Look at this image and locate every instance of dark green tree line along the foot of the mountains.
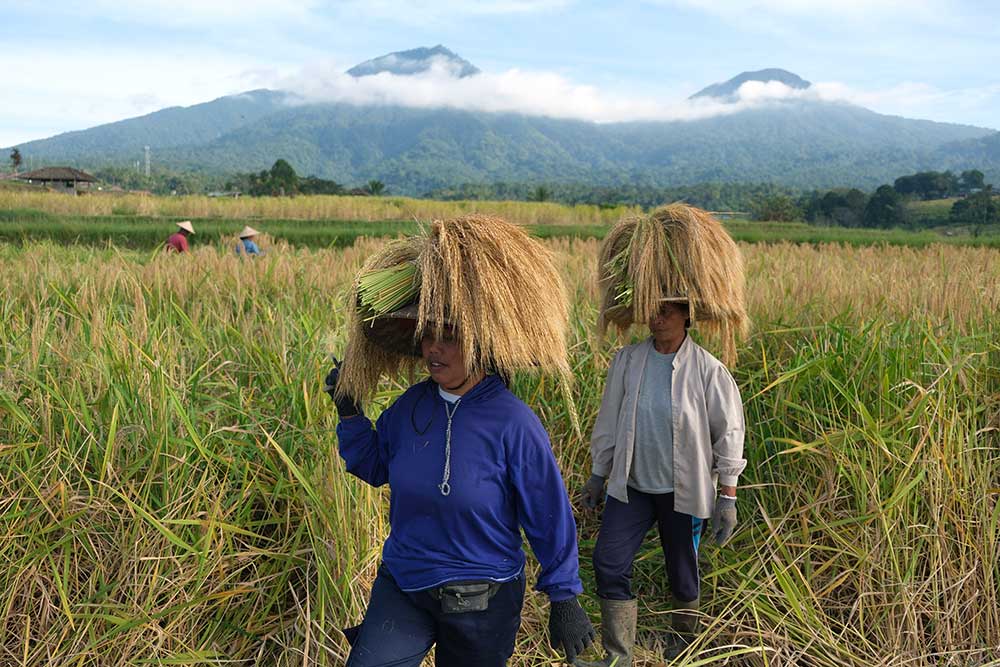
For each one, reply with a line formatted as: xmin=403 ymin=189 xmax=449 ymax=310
xmin=9 ymin=148 xmax=1000 ymax=233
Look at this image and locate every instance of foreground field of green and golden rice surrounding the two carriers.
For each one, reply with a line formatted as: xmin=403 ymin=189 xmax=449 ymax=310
xmin=0 ymin=237 xmax=1000 ymax=667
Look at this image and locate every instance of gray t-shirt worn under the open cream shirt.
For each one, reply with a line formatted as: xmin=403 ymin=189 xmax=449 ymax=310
xmin=628 ymin=347 xmax=674 ymax=493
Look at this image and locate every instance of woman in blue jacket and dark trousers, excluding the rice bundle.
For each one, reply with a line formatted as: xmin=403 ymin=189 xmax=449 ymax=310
xmin=327 ymin=215 xmax=594 ymax=667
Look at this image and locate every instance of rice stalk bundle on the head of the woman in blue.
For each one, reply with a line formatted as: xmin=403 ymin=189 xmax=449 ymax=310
xmin=340 ymin=214 xmax=571 ymax=410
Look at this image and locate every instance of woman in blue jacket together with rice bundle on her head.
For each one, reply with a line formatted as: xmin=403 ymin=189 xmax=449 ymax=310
xmin=326 ymin=215 xmax=594 ymax=667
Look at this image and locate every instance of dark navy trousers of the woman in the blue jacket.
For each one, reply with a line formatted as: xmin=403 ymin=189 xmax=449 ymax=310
xmin=347 ymin=567 xmax=524 ymax=667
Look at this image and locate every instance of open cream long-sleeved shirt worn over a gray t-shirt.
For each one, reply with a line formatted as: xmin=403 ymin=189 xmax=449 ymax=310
xmin=590 ymin=336 xmax=747 ymax=519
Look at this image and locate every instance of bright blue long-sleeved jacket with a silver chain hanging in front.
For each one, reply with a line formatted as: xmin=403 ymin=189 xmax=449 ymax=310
xmin=337 ymin=375 xmax=583 ymax=602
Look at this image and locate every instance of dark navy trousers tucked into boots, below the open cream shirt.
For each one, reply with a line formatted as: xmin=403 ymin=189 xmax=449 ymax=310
xmin=594 ymin=488 xmax=705 ymax=602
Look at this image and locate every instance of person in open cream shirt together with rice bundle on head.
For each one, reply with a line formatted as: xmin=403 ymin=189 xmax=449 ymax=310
xmin=577 ymin=204 xmax=747 ymax=667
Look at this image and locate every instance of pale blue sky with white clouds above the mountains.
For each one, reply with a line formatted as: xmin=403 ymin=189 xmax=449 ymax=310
xmin=0 ymin=0 xmax=1000 ymax=146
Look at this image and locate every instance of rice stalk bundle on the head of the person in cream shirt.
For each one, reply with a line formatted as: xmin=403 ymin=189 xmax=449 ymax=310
xmin=598 ymin=204 xmax=749 ymax=366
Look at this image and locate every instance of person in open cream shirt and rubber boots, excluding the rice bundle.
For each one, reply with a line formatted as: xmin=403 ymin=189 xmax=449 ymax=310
xmin=584 ymin=302 xmax=746 ymax=667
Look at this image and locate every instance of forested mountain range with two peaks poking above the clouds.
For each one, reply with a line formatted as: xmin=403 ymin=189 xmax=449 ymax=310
xmin=8 ymin=54 xmax=1000 ymax=195
